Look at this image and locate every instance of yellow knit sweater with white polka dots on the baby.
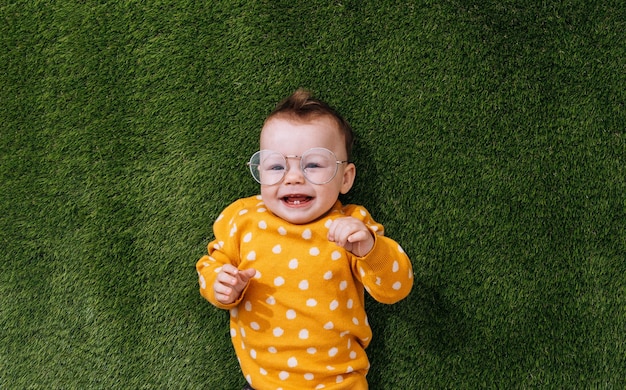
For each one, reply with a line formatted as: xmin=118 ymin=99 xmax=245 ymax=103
xmin=196 ymin=196 xmax=413 ymax=390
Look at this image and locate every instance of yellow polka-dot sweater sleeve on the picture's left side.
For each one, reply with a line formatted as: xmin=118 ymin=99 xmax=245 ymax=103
xmin=196 ymin=201 xmax=245 ymax=309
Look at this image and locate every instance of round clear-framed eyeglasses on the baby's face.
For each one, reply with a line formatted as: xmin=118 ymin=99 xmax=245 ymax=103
xmin=248 ymin=148 xmax=348 ymax=186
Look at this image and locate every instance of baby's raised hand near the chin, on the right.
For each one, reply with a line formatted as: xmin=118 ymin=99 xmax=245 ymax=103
xmin=328 ymin=217 xmax=374 ymax=257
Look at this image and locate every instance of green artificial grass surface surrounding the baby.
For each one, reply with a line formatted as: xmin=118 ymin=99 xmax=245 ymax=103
xmin=0 ymin=0 xmax=626 ymax=389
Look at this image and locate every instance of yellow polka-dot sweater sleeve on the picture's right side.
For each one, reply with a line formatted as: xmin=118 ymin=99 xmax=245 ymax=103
xmin=344 ymin=208 xmax=413 ymax=304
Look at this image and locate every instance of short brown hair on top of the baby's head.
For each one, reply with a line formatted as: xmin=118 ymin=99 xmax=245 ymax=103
xmin=265 ymin=88 xmax=354 ymax=161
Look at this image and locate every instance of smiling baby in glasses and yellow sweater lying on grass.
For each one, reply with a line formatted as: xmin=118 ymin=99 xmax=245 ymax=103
xmin=196 ymin=90 xmax=413 ymax=390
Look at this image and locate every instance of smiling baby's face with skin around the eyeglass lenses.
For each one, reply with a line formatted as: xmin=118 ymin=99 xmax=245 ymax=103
xmin=261 ymin=116 xmax=356 ymax=224
